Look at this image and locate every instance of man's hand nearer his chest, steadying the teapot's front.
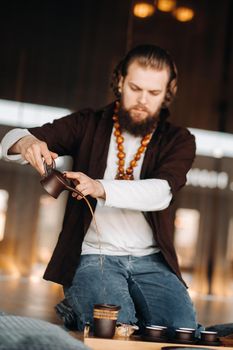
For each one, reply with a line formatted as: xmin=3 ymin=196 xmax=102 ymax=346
xmin=65 ymin=171 xmax=105 ymax=199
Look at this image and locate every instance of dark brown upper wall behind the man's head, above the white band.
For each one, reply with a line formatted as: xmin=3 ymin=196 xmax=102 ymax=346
xmin=0 ymin=0 xmax=233 ymax=132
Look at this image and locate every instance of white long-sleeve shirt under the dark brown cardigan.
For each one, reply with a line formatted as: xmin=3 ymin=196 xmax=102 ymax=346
xmin=2 ymin=129 xmax=172 ymax=256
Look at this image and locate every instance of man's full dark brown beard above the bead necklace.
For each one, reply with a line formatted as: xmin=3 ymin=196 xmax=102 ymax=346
xmin=118 ymin=104 xmax=161 ymax=137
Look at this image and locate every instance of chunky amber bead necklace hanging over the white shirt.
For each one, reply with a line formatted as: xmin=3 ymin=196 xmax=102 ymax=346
xmin=113 ymin=101 xmax=153 ymax=180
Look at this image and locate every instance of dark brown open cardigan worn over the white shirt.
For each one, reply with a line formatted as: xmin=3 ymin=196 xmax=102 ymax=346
xmin=29 ymin=104 xmax=195 ymax=285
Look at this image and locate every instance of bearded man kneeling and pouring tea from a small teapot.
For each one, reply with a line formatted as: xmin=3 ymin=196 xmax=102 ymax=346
xmin=2 ymin=45 xmax=198 ymax=330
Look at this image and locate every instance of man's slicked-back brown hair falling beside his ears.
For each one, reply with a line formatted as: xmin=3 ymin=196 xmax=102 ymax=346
xmin=111 ymin=45 xmax=177 ymax=109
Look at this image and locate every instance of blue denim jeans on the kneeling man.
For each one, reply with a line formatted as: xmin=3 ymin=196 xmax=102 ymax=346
xmin=64 ymin=253 xmax=198 ymax=330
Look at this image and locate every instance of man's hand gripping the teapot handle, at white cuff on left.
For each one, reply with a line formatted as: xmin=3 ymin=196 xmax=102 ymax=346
xmin=8 ymin=135 xmax=58 ymax=175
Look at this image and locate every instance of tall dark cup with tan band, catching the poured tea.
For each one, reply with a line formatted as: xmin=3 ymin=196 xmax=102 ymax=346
xmin=93 ymin=304 xmax=121 ymax=338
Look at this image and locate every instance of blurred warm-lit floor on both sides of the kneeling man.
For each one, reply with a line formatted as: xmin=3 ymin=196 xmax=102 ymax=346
xmin=0 ymin=276 xmax=233 ymax=326
